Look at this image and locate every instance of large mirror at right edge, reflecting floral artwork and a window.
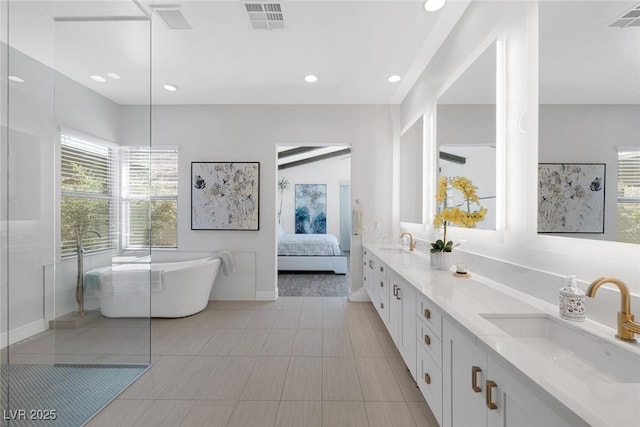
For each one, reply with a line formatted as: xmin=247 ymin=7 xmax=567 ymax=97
xmin=538 ymin=0 xmax=640 ymax=243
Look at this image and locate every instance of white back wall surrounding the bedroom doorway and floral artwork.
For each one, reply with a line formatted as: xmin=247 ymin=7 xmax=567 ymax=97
xmin=117 ymin=105 xmax=394 ymax=299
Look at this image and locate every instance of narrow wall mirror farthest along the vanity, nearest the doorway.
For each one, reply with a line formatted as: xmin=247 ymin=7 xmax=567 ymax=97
xmin=400 ymin=116 xmax=424 ymax=224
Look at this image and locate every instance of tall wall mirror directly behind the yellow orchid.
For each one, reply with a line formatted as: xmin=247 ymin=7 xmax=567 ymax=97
xmin=436 ymin=42 xmax=497 ymax=230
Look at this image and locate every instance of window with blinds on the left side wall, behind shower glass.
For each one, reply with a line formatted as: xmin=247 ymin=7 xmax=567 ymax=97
xmin=60 ymin=133 xmax=116 ymax=257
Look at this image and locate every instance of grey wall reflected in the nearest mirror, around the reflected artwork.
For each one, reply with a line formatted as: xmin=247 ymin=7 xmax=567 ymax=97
xmin=539 ymin=105 xmax=640 ymax=240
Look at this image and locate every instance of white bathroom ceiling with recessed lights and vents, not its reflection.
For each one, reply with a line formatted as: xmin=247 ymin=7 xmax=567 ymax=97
xmin=2 ymin=0 xmax=468 ymax=105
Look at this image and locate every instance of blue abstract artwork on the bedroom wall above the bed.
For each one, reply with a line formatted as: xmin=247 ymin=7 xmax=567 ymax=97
xmin=296 ymin=184 xmax=327 ymax=234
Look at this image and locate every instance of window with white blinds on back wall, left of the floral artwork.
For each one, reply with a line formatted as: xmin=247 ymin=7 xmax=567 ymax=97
xmin=122 ymin=147 xmax=178 ymax=249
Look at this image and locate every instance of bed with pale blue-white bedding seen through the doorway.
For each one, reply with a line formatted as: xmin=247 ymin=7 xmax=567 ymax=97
xmin=278 ymin=227 xmax=347 ymax=274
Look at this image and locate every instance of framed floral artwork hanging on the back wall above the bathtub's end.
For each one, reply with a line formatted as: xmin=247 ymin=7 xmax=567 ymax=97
xmin=191 ymin=162 xmax=260 ymax=230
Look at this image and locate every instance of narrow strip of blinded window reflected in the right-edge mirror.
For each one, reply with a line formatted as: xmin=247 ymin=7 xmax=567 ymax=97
xmin=616 ymin=149 xmax=640 ymax=243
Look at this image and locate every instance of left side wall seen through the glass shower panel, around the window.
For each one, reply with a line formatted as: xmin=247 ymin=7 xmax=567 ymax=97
xmin=0 ymin=45 xmax=120 ymax=342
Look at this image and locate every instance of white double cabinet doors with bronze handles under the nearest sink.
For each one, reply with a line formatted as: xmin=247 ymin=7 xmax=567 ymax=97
xmin=441 ymin=321 xmax=584 ymax=427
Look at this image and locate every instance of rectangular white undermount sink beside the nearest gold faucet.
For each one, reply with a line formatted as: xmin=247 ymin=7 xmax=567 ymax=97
xmin=481 ymin=314 xmax=640 ymax=383
